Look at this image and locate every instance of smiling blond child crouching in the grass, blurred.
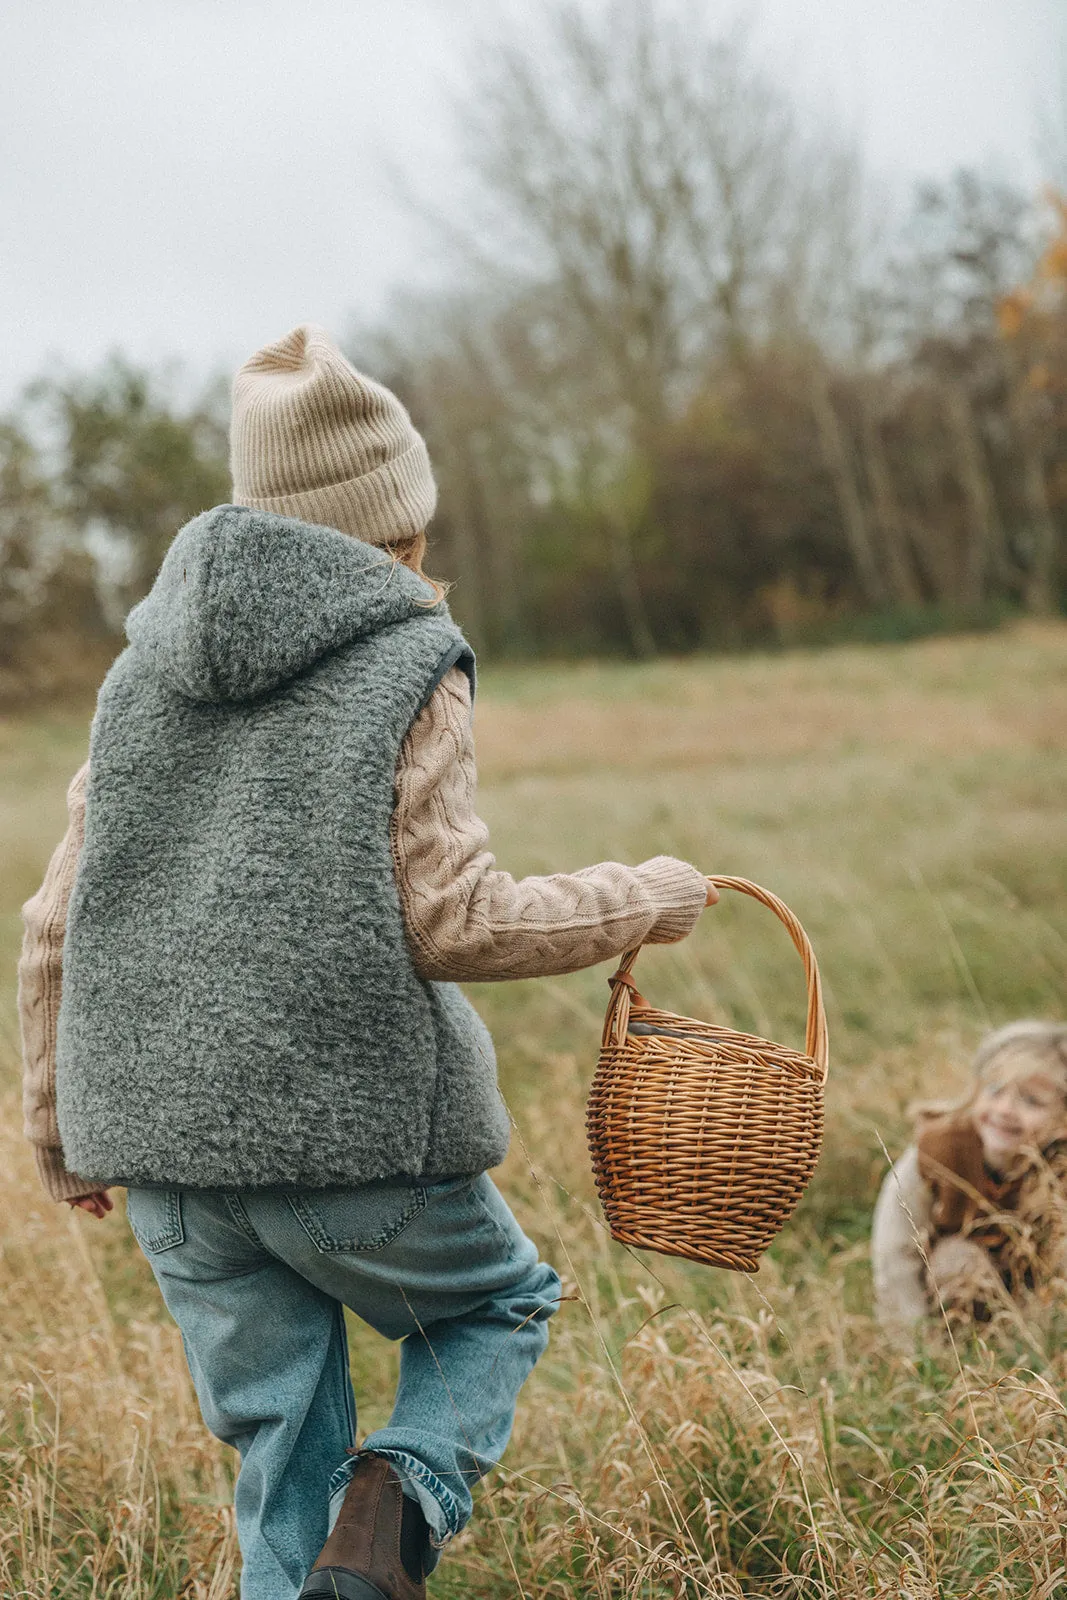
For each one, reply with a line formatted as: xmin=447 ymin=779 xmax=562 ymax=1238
xmin=870 ymin=1022 xmax=1067 ymax=1333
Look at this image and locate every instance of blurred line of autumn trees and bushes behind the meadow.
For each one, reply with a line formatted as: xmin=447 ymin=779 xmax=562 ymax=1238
xmin=0 ymin=0 xmax=1067 ymax=699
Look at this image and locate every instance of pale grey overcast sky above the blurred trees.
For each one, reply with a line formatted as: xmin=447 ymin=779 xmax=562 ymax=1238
xmin=0 ymin=0 xmax=1067 ymax=403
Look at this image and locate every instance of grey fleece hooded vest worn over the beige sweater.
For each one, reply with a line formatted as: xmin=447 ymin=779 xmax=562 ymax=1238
xmin=56 ymin=506 xmax=507 ymax=1189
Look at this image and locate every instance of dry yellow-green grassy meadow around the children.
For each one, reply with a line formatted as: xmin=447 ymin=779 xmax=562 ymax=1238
xmin=0 ymin=626 xmax=1067 ymax=1600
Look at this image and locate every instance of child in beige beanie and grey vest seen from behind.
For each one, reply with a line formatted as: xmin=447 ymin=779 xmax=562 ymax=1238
xmin=19 ymin=326 xmax=717 ymax=1600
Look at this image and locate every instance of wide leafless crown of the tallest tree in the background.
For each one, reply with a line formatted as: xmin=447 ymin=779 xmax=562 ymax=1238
xmin=462 ymin=0 xmax=870 ymax=412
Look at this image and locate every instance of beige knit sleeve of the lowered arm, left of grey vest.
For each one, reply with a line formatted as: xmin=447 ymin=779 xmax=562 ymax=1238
xmin=19 ymin=765 xmax=96 ymax=1200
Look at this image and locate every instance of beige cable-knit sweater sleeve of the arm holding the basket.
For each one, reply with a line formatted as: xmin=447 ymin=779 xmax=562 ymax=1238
xmin=392 ymin=669 xmax=707 ymax=982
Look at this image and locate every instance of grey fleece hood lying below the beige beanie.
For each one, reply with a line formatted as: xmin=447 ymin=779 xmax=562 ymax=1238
xmin=126 ymin=506 xmax=448 ymax=701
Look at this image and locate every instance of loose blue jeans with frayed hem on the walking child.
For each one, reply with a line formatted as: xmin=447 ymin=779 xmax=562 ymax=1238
xmin=126 ymin=1174 xmax=560 ymax=1600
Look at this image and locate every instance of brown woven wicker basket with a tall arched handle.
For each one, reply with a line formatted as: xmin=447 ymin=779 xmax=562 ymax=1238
xmin=587 ymin=877 xmax=829 ymax=1272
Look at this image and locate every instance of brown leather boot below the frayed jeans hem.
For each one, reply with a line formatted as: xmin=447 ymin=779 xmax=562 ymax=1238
xmin=299 ymin=1456 xmax=429 ymax=1600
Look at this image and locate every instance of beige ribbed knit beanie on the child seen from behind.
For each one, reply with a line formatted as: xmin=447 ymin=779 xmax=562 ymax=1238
xmin=230 ymin=323 xmax=437 ymax=544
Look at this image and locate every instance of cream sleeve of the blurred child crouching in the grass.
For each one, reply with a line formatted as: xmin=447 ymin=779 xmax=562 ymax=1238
xmin=870 ymin=1144 xmax=931 ymax=1336
